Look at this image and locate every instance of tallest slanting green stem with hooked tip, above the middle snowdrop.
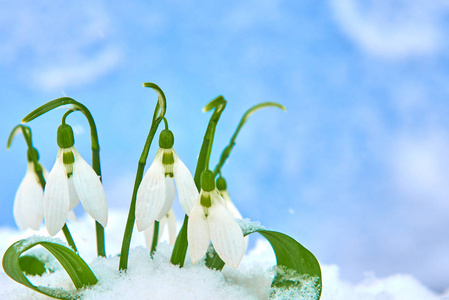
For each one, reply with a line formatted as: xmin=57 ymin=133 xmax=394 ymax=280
xmin=119 ymin=83 xmax=166 ymax=271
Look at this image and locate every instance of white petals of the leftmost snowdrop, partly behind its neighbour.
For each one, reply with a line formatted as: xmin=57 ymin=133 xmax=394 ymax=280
xmin=13 ymin=162 xmax=47 ymax=230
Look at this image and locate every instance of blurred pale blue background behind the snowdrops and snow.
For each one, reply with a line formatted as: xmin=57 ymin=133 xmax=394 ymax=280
xmin=0 ymin=0 xmax=449 ymax=291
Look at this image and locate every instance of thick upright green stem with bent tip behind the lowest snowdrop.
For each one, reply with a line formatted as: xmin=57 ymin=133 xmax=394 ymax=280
xmin=170 ymin=96 xmax=226 ymax=268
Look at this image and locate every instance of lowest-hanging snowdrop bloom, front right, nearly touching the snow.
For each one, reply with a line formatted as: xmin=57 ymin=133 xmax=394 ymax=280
xmin=187 ymin=170 xmax=245 ymax=268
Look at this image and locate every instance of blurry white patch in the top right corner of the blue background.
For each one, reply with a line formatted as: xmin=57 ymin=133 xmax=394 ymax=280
xmin=331 ymin=0 xmax=449 ymax=59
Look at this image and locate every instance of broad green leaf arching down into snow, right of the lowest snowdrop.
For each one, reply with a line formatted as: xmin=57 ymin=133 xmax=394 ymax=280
xmin=206 ymin=228 xmax=321 ymax=299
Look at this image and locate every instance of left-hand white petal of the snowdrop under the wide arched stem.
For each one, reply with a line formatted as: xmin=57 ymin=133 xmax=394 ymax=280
xmin=44 ymin=149 xmax=70 ymax=236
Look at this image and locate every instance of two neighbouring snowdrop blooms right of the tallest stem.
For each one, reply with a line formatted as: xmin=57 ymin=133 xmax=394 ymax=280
xmin=136 ymin=130 xmax=245 ymax=268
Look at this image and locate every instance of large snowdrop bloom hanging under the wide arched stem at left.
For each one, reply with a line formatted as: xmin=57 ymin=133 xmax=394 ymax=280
xmin=44 ymin=124 xmax=108 ymax=236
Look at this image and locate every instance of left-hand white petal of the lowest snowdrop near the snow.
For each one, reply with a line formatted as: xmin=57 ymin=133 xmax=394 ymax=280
xmin=187 ymin=198 xmax=210 ymax=264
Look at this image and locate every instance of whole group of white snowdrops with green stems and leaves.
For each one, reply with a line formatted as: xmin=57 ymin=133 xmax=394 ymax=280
xmin=3 ymin=87 xmax=321 ymax=299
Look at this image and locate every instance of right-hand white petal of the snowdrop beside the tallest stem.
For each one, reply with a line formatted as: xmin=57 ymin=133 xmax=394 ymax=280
xmin=173 ymin=150 xmax=199 ymax=215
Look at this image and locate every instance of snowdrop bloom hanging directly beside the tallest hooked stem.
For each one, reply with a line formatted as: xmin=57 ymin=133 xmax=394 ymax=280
xmin=136 ymin=129 xmax=198 ymax=231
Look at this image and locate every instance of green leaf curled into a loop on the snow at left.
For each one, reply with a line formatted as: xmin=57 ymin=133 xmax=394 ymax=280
xmin=3 ymin=237 xmax=98 ymax=300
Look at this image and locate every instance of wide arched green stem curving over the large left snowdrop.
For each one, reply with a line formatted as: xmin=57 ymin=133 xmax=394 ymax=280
xmin=22 ymin=97 xmax=106 ymax=257
